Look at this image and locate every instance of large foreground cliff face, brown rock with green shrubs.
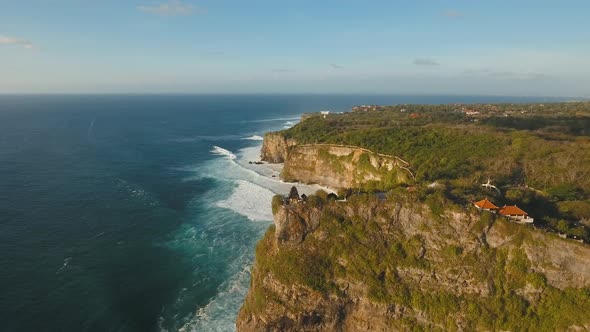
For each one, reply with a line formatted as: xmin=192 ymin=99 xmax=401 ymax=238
xmin=237 ymin=196 xmax=590 ymax=331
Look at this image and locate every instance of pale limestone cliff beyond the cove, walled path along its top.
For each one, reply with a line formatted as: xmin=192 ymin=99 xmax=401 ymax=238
xmin=281 ymin=144 xmax=413 ymax=188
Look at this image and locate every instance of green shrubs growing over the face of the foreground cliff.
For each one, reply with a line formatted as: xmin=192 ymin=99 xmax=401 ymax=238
xmin=245 ymin=191 xmax=590 ymax=331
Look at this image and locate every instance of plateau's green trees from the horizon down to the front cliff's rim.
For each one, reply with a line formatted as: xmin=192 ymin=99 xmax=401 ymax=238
xmin=281 ymin=102 xmax=590 ymax=242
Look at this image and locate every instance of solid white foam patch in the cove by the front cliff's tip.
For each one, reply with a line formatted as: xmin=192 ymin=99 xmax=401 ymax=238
xmin=216 ymin=180 xmax=274 ymax=221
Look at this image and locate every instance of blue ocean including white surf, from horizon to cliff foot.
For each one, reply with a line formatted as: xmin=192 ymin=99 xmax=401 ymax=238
xmin=0 ymin=95 xmax=568 ymax=331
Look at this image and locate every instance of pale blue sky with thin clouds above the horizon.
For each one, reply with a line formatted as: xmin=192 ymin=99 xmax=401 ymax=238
xmin=0 ymin=0 xmax=590 ymax=97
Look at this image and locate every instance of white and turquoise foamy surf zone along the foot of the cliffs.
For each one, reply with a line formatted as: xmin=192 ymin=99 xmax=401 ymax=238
xmin=169 ymin=144 xmax=340 ymax=332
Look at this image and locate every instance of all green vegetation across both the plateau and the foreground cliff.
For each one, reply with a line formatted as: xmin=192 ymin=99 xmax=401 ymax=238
xmin=244 ymin=102 xmax=590 ymax=331
